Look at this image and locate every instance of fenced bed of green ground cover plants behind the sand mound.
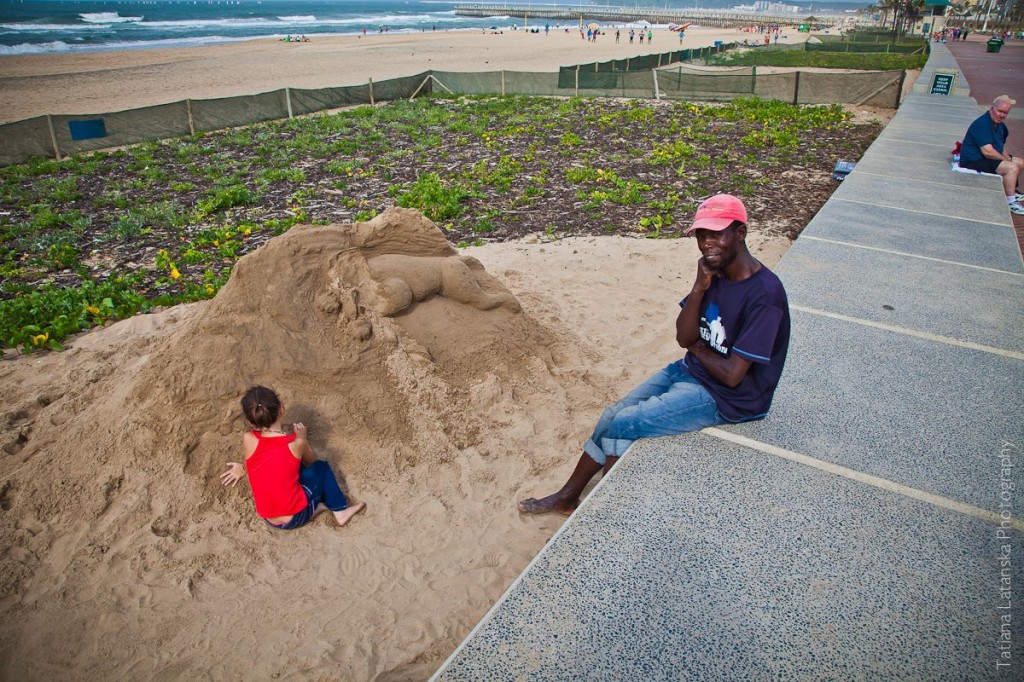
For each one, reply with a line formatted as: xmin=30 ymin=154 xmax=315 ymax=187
xmin=0 ymin=94 xmax=881 ymax=350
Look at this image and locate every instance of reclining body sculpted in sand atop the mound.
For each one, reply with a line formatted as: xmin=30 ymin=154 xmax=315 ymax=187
xmin=367 ymin=254 xmax=520 ymax=316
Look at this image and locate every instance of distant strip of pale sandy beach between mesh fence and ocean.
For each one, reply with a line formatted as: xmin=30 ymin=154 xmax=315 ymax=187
xmin=0 ymin=27 xmax=807 ymax=123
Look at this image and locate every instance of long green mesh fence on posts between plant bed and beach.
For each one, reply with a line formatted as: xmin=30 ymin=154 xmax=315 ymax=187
xmin=0 ymin=53 xmax=903 ymax=165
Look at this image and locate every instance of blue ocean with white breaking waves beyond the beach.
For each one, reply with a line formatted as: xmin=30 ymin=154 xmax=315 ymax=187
xmin=0 ymin=0 xmax=514 ymax=55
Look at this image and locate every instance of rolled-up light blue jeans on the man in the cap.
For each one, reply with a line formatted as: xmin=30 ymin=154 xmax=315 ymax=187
xmin=583 ymin=359 xmax=727 ymax=465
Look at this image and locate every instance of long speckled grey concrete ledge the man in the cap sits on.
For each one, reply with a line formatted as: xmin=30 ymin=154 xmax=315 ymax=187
xmin=434 ymin=45 xmax=1024 ymax=682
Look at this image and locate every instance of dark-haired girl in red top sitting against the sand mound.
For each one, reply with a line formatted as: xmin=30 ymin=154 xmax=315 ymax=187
xmin=220 ymin=386 xmax=367 ymax=530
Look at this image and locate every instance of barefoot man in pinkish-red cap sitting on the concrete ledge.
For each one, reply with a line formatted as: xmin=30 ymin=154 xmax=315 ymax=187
xmin=519 ymin=195 xmax=790 ymax=514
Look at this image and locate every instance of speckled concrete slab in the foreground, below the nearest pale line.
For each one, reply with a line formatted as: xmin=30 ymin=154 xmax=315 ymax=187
xmin=434 ymin=434 xmax=1024 ymax=682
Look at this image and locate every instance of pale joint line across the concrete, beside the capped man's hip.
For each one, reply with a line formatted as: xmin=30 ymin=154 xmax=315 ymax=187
xmin=701 ymin=427 xmax=1024 ymax=530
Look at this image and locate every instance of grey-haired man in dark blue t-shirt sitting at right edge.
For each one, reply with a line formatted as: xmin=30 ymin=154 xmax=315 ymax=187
xmin=959 ymin=95 xmax=1024 ymax=215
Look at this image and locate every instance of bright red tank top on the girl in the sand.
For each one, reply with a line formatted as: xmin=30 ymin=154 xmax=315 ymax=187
xmin=246 ymin=431 xmax=309 ymax=518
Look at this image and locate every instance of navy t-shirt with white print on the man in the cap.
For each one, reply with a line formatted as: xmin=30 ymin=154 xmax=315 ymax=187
xmin=679 ymin=265 xmax=790 ymax=422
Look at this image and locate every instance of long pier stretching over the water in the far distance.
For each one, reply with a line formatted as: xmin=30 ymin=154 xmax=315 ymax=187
xmin=455 ymin=2 xmax=837 ymax=28
